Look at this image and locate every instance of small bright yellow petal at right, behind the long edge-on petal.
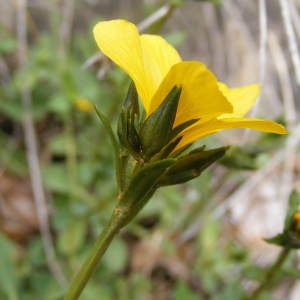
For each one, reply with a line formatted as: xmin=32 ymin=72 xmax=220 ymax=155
xmin=218 ymin=82 xmax=260 ymax=118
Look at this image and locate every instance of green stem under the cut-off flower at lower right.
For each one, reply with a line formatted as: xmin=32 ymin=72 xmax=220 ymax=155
xmin=246 ymin=248 xmax=290 ymax=300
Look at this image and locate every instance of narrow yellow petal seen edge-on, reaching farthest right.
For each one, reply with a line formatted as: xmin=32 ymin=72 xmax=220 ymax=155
xmin=176 ymin=118 xmax=287 ymax=149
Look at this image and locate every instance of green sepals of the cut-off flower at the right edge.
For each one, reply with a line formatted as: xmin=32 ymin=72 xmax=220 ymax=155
xmin=265 ymin=191 xmax=300 ymax=249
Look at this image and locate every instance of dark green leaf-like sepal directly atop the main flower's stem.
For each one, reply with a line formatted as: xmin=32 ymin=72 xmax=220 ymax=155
xmin=117 ymin=158 xmax=175 ymax=223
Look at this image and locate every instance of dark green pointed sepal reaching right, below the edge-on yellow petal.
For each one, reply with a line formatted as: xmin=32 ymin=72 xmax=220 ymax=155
xmin=159 ymin=147 xmax=228 ymax=186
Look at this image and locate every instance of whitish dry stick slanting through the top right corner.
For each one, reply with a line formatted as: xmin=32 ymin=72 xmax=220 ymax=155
xmin=278 ymin=0 xmax=300 ymax=85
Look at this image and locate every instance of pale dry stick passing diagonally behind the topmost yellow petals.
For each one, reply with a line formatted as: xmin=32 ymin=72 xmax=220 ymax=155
xmin=82 ymin=3 xmax=176 ymax=69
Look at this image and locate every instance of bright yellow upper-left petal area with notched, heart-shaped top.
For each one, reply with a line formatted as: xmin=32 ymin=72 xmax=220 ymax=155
xmin=94 ymin=20 xmax=181 ymax=112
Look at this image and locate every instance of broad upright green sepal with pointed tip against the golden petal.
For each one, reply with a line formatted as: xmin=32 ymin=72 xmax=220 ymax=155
xmin=140 ymin=86 xmax=181 ymax=161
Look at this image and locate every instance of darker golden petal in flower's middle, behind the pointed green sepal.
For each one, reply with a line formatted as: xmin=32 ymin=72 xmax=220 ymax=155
xmin=150 ymin=61 xmax=232 ymax=126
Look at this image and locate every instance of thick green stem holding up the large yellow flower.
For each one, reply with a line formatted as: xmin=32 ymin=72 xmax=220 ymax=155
xmin=63 ymin=210 xmax=124 ymax=300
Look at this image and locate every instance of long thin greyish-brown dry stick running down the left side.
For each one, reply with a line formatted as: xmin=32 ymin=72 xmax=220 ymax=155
xmin=17 ymin=0 xmax=66 ymax=286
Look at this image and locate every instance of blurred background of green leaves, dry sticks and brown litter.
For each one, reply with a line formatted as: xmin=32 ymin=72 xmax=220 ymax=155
xmin=0 ymin=0 xmax=300 ymax=300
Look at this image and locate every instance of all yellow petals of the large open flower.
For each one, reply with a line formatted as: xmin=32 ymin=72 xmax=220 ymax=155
xmin=94 ymin=20 xmax=286 ymax=149
